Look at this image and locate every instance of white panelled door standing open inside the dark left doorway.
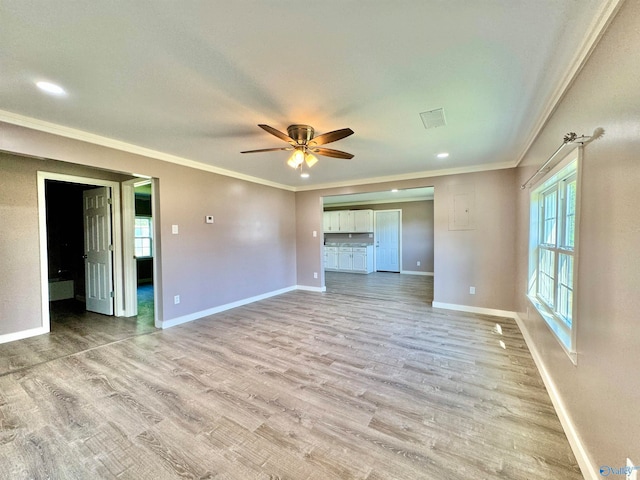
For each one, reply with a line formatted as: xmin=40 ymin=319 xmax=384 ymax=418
xmin=83 ymin=187 xmax=113 ymax=315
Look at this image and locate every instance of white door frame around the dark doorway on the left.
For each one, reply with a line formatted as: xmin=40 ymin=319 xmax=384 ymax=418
xmin=37 ymin=171 xmax=124 ymax=333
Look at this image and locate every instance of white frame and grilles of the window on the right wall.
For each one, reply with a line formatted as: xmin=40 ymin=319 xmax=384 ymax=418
xmin=527 ymin=147 xmax=582 ymax=364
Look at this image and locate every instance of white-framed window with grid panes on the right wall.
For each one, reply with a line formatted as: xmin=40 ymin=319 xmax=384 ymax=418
xmin=528 ymin=151 xmax=580 ymax=362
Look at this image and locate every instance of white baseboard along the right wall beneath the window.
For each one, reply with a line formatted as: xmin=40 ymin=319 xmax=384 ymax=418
xmin=513 ymin=313 xmax=602 ymax=480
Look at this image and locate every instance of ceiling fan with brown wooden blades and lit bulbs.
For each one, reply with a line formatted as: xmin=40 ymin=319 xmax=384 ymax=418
xmin=240 ymin=124 xmax=353 ymax=168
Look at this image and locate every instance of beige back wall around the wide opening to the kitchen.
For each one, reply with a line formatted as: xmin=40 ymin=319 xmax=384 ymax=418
xmin=296 ymin=169 xmax=517 ymax=312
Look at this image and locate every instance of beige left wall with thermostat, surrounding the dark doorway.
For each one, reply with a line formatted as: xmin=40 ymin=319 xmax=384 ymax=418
xmin=0 ymin=124 xmax=296 ymax=335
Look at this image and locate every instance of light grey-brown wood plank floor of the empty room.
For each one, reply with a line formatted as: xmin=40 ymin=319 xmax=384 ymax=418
xmin=0 ymin=275 xmax=582 ymax=480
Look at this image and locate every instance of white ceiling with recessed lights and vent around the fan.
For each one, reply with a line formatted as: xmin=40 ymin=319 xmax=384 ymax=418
xmin=0 ymin=0 xmax=619 ymax=190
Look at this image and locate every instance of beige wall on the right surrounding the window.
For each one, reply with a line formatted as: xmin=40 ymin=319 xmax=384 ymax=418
xmin=515 ymin=0 xmax=640 ymax=472
